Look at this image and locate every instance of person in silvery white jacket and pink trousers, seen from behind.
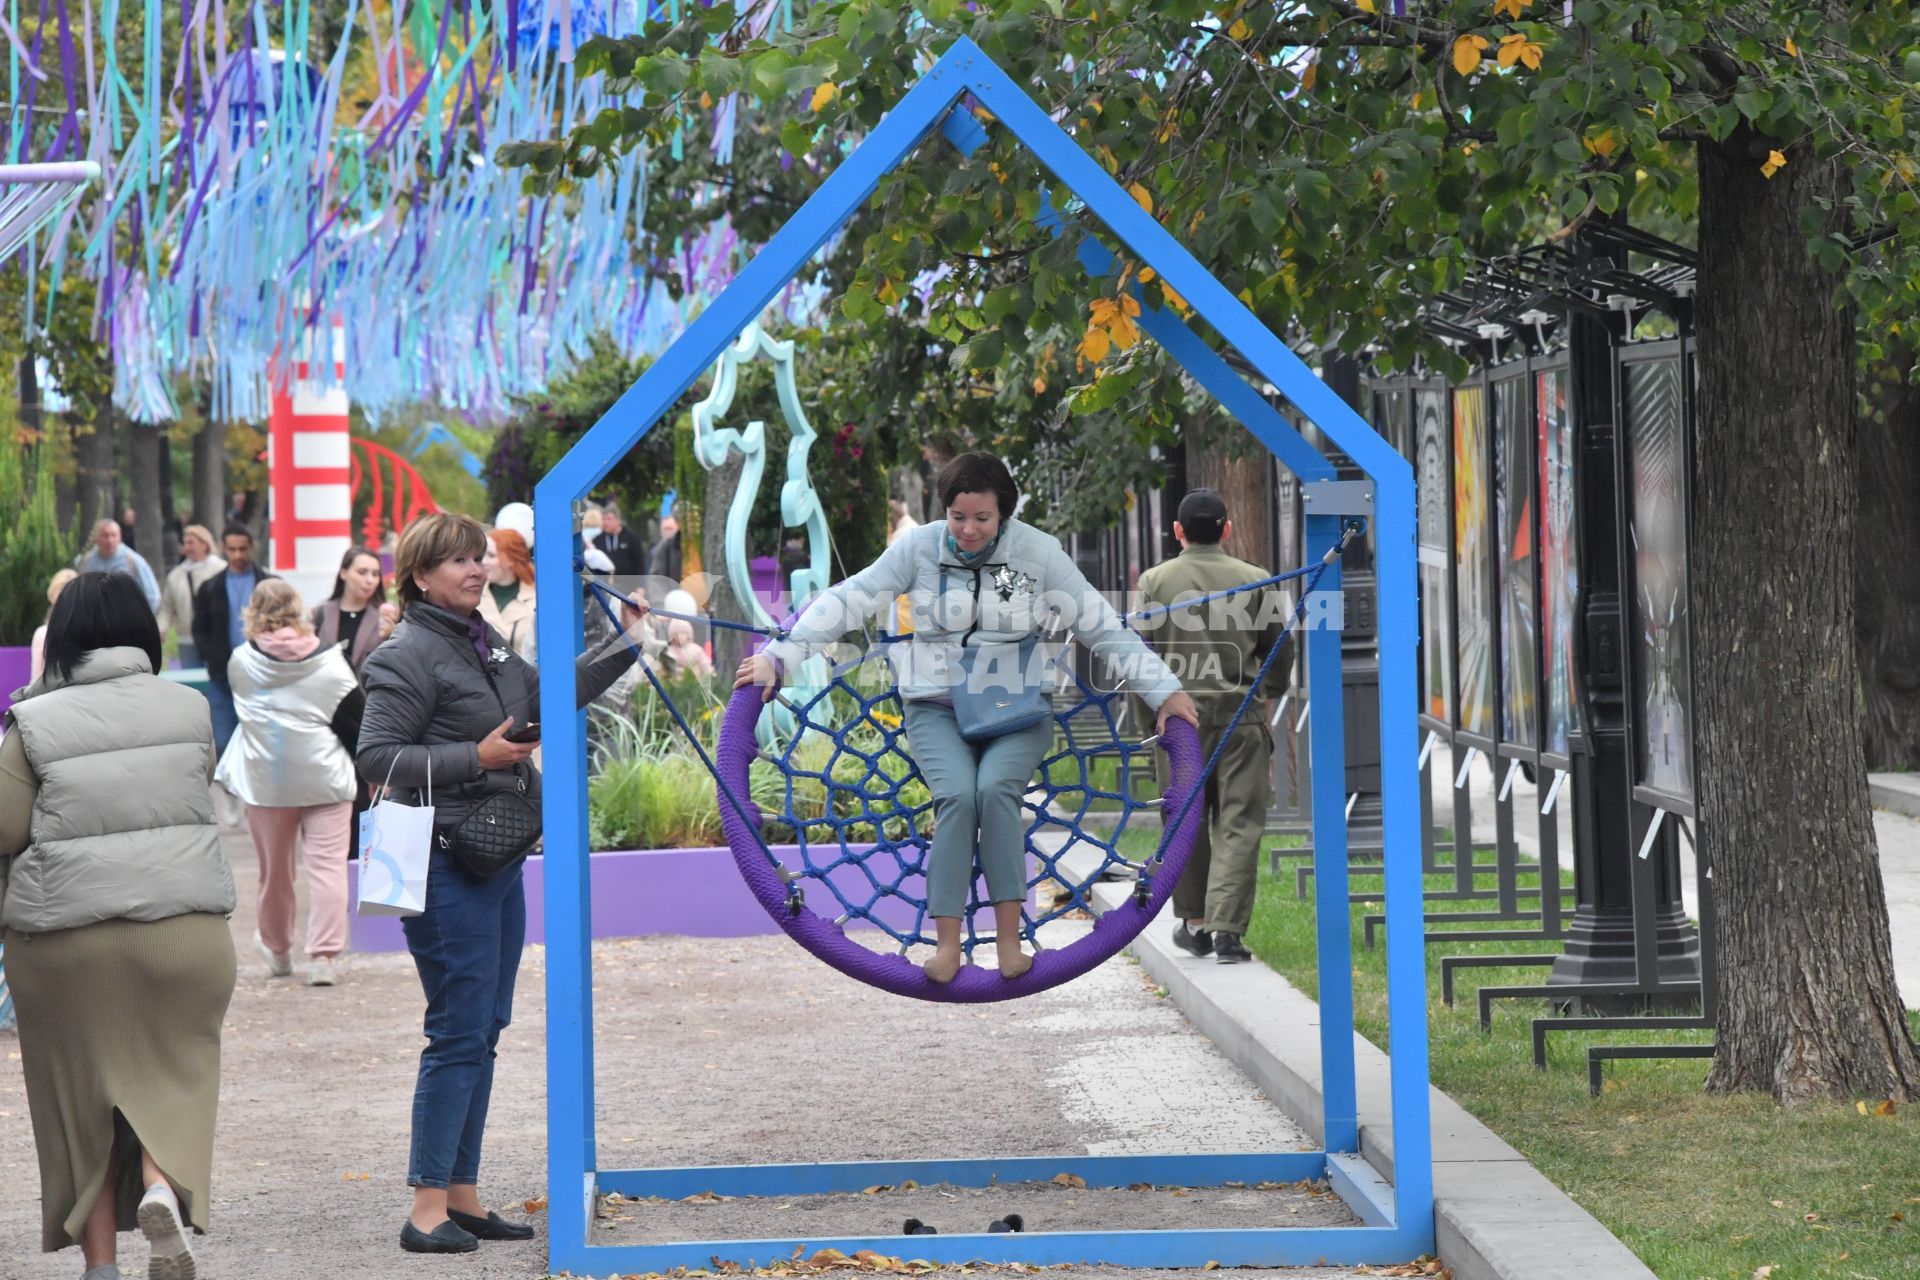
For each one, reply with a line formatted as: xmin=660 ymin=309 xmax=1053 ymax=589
xmin=215 ymin=578 xmax=367 ymax=986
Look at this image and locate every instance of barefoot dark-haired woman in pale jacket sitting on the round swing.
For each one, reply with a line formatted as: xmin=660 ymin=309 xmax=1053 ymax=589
xmin=733 ymin=453 xmax=1200 ymax=983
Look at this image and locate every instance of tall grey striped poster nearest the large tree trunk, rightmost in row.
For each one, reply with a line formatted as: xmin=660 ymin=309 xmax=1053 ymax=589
xmin=1626 ymin=359 xmax=1693 ymax=800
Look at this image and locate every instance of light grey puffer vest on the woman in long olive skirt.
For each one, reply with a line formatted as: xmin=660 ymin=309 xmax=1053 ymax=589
xmin=0 ymin=649 xmax=234 ymax=933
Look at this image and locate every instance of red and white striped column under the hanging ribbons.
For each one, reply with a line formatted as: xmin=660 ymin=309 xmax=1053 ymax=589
xmin=267 ymin=322 xmax=353 ymax=599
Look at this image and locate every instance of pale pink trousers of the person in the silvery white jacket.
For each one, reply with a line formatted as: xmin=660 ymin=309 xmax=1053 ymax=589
xmin=246 ymin=800 xmax=353 ymax=956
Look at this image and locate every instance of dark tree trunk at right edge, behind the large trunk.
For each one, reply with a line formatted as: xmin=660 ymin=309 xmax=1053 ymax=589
xmin=1853 ymin=347 xmax=1920 ymax=770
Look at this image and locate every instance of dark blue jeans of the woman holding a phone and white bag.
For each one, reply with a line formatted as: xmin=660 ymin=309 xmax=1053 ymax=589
xmin=401 ymin=848 xmax=526 ymax=1188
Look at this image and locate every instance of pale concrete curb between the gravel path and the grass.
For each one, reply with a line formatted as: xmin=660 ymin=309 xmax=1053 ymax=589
xmin=1092 ymin=883 xmax=1655 ymax=1280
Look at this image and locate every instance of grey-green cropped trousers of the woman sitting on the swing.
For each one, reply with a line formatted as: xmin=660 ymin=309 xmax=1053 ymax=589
xmin=906 ymin=702 xmax=1054 ymax=917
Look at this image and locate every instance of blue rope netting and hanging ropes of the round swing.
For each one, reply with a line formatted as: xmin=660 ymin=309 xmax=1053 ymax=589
xmin=586 ymin=524 xmax=1359 ymax=998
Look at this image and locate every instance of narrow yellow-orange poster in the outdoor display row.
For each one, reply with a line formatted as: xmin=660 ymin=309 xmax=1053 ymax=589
xmin=1453 ymin=386 xmax=1494 ymax=739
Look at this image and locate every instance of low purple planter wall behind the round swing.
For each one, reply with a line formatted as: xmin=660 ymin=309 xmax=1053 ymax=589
xmin=348 ymin=844 xmax=940 ymax=952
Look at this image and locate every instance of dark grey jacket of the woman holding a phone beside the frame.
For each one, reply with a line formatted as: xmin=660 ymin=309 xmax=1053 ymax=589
xmin=355 ymin=603 xmax=648 ymax=827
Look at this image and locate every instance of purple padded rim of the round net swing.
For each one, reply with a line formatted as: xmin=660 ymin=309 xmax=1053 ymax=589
xmin=714 ymin=685 xmax=1206 ymax=1004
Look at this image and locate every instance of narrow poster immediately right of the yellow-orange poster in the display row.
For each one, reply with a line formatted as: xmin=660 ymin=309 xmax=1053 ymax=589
xmin=1494 ymin=378 xmax=1540 ymax=748
